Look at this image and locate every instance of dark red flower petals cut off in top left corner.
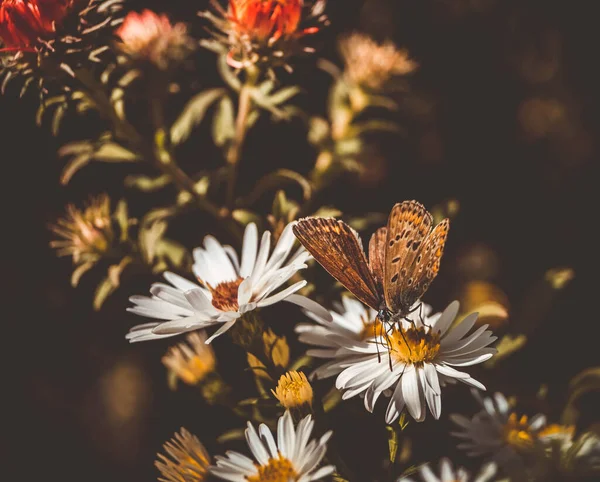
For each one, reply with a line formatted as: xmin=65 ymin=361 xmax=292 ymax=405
xmin=0 ymin=0 xmax=73 ymax=50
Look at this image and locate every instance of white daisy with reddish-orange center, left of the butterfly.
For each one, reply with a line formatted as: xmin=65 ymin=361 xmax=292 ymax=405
xmin=127 ymin=223 xmax=329 ymax=343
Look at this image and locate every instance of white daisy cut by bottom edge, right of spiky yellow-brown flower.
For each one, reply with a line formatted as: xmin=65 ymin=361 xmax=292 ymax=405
xmin=210 ymin=411 xmax=335 ymax=482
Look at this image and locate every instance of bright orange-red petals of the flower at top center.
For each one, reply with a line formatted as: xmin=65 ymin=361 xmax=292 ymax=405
xmin=229 ymin=0 xmax=303 ymax=43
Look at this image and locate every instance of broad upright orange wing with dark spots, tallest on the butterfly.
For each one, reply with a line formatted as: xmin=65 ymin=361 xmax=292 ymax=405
xmin=383 ymin=201 xmax=433 ymax=313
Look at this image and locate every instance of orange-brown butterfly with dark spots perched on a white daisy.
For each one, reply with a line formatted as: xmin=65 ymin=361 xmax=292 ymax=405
xmin=293 ymin=201 xmax=450 ymax=322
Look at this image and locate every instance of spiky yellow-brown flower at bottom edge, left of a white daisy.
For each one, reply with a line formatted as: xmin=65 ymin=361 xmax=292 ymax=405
xmin=155 ymin=428 xmax=210 ymax=482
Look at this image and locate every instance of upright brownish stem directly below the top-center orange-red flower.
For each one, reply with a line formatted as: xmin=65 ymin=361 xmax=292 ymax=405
xmin=226 ymin=67 xmax=259 ymax=209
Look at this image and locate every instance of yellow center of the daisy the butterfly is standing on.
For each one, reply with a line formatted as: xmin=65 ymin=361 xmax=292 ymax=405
xmin=388 ymin=326 xmax=440 ymax=364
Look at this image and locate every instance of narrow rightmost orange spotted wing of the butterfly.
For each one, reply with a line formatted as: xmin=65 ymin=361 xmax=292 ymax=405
xmin=400 ymin=219 xmax=450 ymax=309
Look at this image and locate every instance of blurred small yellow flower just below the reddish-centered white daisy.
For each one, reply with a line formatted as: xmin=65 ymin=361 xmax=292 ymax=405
xmin=162 ymin=332 xmax=217 ymax=385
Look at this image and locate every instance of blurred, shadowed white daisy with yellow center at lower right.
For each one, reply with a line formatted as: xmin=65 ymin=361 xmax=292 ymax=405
xmin=450 ymin=391 xmax=546 ymax=473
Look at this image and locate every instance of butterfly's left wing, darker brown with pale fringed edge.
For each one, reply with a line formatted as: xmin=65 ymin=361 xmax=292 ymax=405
xmin=293 ymin=218 xmax=380 ymax=310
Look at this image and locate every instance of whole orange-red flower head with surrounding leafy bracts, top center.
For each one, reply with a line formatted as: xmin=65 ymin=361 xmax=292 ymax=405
xmin=201 ymin=0 xmax=326 ymax=70
